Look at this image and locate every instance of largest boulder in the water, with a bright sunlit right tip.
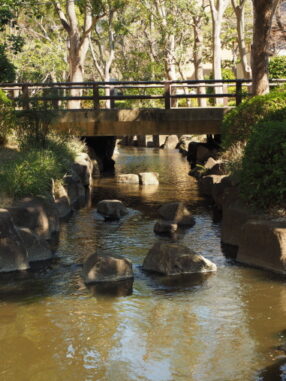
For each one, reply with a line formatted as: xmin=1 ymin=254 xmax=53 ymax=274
xmin=143 ymin=242 xmax=217 ymax=275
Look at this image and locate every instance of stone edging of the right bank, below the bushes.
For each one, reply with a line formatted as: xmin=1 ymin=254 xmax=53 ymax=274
xmin=187 ymin=143 xmax=286 ymax=275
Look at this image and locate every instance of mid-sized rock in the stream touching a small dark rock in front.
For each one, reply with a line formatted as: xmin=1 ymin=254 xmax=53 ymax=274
xmin=159 ymin=202 xmax=195 ymax=226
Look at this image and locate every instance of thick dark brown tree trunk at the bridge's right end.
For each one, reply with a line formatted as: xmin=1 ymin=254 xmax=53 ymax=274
xmin=251 ymin=0 xmax=279 ymax=95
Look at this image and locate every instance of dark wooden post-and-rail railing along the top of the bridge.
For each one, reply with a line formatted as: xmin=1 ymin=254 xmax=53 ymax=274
xmin=0 ymin=79 xmax=286 ymax=109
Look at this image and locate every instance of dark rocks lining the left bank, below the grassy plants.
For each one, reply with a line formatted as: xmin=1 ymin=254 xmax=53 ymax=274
xmin=0 ymin=153 xmax=94 ymax=272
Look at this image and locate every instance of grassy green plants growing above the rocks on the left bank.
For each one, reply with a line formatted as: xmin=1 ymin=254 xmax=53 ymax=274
xmin=0 ymin=136 xmax=86 ymax=198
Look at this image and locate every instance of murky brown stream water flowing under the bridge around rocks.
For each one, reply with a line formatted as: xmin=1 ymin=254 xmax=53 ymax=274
xmin=0 ymin=148 xmax=286 ymax=381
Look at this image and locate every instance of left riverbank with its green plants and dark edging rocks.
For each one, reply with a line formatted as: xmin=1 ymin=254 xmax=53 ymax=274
xmin=0 ymin=138 xmax=98 ymax=272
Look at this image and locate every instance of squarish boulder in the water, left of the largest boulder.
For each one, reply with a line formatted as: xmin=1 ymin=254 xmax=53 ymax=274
xmin=83 ymin=253 xmax=134 ymax=283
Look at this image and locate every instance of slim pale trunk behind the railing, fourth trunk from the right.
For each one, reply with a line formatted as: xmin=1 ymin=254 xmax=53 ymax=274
xmin=193 ymin=16 xmax=207 ymax=107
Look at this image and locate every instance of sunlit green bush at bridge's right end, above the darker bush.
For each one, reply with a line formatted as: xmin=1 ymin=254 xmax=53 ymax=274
xmin=222 ymin=89 xmax=286 ymax=149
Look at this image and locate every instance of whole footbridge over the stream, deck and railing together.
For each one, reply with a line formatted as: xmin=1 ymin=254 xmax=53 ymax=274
xmin=0 ymin=80 xmax=285 ymax=136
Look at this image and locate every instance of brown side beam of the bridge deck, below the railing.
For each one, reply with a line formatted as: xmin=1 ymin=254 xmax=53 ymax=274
xmin=52 ymin=107 xmax=230 ymax=136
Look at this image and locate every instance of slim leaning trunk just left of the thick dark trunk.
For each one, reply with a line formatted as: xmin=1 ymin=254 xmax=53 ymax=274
xmin=231 ymin=0 xmax=251 ymax=79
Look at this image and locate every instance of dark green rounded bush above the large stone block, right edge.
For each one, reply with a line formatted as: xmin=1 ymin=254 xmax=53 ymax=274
xmin=240 ymin=122 xmax=286 ymax=209
